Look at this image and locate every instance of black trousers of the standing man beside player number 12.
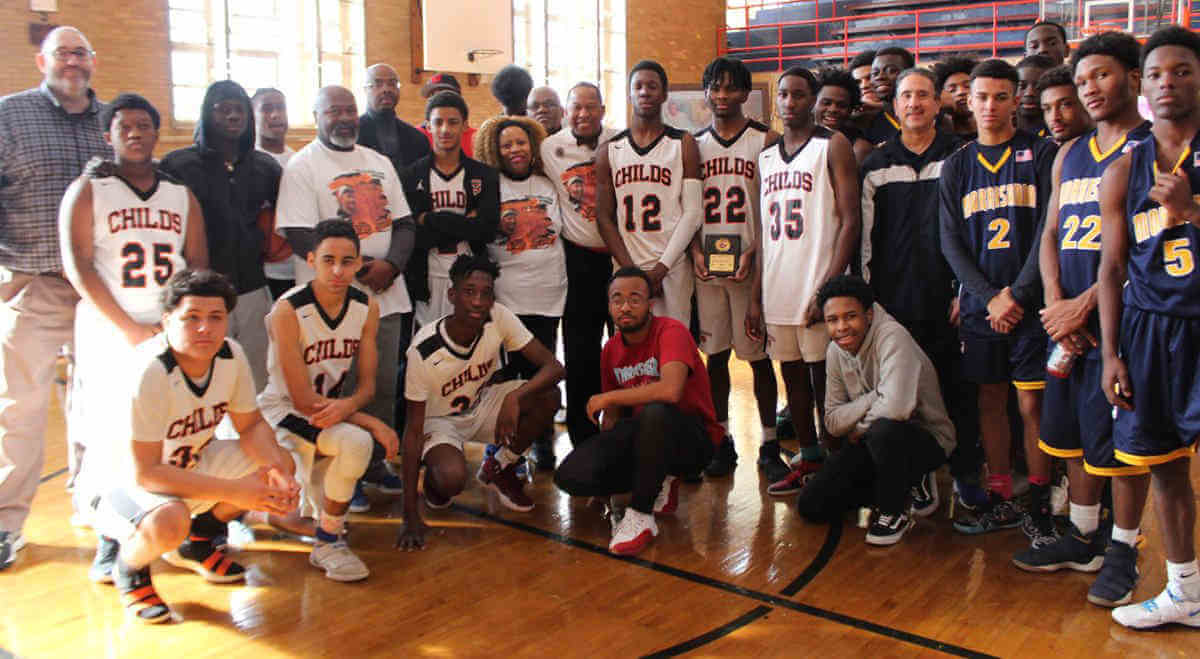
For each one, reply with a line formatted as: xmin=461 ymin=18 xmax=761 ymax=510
xmin=563 ymin=240 xmax=612 ymax=445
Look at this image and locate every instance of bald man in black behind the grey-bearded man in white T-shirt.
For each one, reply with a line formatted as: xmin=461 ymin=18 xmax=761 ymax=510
xmin=359 ymin=64 xmax=433 ymax=172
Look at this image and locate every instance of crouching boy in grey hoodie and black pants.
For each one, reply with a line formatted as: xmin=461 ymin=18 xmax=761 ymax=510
xmin=797 ymin=275 xmax=954 ymax=545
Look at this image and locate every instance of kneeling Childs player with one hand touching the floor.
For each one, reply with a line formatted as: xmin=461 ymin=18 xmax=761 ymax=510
xmin=396 ymin=254 xmax=564 ymax=551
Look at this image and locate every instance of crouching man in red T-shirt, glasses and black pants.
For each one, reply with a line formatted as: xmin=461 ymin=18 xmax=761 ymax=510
xmin=554 ymin=266 xmax=725 ymax=555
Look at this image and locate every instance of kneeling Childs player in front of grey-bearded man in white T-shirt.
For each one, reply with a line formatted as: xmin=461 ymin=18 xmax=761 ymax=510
xmin=259 ymin=220 xmax=400 ymax=581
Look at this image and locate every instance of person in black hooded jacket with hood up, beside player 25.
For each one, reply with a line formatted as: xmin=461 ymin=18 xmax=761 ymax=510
xmin=161 ymin=80 xmax=282 ymax=389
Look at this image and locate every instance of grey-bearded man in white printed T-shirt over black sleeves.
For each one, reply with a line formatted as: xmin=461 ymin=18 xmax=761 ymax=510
xmin=277 ymin=86 xmax=414 ymax=513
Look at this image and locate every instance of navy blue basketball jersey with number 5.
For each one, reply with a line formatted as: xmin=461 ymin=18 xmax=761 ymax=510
xmin=1124 ymin=133 xmax=1200 ymax=318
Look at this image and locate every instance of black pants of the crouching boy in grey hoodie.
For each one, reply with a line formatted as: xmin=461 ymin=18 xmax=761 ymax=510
xmin=796 ymin=419 xmax=946 ymax=522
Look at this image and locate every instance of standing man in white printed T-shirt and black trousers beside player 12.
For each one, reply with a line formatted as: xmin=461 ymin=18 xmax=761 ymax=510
xmin=534 ymin=83 xmax=617 ymax=446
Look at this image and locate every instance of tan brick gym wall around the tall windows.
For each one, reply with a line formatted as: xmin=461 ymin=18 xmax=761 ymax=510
xmin=0 ymin=0 xmax=725 ymax=151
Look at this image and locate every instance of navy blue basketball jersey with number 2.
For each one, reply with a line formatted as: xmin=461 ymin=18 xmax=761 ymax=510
xmin=942 ymin=131 xmax=1057 ymax=313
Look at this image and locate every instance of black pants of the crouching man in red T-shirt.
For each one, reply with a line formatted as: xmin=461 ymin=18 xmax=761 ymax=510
xmin=554 ymin=403 xmax=713 ymax=514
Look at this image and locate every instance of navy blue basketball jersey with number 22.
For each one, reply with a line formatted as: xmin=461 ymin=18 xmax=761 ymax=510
xmin=1056 ymin=121 xmax=1151 ymax=314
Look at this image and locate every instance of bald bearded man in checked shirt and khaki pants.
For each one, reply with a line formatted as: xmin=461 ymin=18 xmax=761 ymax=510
xmin=0 ymin=28 xmax=113 ymax=570
